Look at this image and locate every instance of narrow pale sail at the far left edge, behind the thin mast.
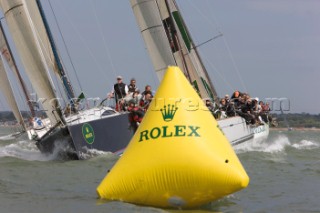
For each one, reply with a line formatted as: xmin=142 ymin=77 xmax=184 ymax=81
xmin=0 ymin=55 xmax=25 ymax=130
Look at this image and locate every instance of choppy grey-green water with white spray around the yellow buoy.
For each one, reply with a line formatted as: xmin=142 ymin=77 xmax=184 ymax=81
xmin=0 ymin=128 xmax=320 ymax=213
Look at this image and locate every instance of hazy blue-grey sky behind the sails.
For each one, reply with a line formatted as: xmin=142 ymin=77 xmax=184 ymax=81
xmin=0 ymin=0 xmax=320 ymax=114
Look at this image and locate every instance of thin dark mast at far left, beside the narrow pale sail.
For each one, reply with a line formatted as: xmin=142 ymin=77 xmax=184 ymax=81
xmin=0 ymin=21 xmax=36 ymax=117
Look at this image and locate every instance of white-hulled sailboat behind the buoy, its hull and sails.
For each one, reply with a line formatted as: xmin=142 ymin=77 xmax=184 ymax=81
xmin=130 ymin=0 xmax=269 ymax=146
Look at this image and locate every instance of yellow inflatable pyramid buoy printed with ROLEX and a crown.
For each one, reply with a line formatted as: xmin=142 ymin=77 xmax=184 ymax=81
xmin=97 ymin=67 xmax=249 ymax=208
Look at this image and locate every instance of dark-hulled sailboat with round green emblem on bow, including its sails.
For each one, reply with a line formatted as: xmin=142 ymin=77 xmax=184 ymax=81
xmin=0 ymin=0 xmax=133 ymax=159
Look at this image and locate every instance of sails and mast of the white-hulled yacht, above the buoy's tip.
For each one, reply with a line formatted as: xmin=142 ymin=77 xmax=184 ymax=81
xmin=130 ymin=0 xmax=217 ymax=100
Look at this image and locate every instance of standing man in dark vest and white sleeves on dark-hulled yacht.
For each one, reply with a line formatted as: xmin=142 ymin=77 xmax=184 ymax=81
xmin=108 ymin=75 xmax=129 ymax=111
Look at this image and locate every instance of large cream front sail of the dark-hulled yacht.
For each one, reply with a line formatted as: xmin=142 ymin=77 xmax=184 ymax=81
xmin=0 ymin=0 xmax=63 ymax=125
